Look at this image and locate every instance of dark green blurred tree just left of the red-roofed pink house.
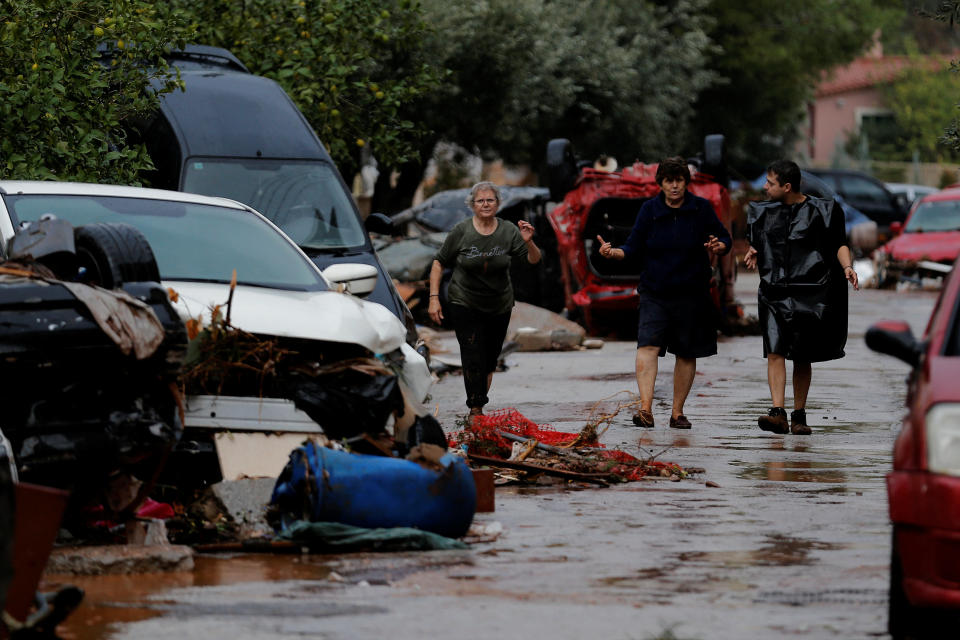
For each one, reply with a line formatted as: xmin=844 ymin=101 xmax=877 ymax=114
xmin=694 ymin=0 xmax=904 ymax=172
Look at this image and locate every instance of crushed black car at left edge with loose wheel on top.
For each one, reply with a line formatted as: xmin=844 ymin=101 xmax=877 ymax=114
xmin=0 ymin=210 xmax=187 ymax=518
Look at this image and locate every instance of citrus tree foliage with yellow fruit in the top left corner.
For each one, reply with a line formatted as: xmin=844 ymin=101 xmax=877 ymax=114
xmin=0 ymin=0 xmax=186 ymax=184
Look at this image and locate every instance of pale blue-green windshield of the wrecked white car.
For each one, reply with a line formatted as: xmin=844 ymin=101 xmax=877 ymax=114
xmin=5 ymin=195 xmax=327 ymax=291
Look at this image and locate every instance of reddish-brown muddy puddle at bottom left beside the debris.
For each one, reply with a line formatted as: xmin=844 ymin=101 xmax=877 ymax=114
xmin=47 ymin=554 xmax=330 ymax=640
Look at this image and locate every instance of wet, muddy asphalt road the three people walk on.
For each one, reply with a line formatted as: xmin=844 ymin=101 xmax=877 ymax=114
xmin=75 ymin=275 xmax=935 ymax=640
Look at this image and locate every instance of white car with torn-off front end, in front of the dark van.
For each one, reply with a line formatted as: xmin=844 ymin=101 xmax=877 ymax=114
xmin=0 ymin=181 xmax=432 ymax=476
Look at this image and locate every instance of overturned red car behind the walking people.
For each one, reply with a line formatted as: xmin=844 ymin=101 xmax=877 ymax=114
xmin=547 ymin=136 xmax=743 ymax=332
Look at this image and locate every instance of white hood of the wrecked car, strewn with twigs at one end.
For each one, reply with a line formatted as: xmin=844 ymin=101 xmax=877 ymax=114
xmin=164 ymin=280 xmax=406 ymax=354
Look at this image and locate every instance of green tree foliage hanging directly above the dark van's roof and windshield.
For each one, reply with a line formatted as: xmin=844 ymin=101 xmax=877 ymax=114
xmin=169 ymin=0 xmax=441 ymax=175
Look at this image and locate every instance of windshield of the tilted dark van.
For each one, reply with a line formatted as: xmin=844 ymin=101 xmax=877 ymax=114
xmin=183 ymin=158 xmax=367 ymax=250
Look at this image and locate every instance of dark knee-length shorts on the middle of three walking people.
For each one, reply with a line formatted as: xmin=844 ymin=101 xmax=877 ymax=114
xmin=637 ymin=291 xmax=717 ymax=358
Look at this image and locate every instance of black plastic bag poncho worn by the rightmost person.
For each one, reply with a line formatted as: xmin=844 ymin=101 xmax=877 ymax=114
xmin=747 ymin=196 xmax=847 ymax=362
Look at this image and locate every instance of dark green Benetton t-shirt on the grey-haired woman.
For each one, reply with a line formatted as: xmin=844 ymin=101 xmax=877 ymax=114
xmin=436 ymin=218 xmax=527 ymax=314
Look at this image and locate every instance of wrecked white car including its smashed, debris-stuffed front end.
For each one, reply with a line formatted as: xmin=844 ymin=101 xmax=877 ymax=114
xmin=0 ymin=182 xmax=432 ymax=488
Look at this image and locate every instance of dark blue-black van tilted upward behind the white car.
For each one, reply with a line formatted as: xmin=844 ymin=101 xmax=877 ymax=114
xmin=124 ymin=46 xmax=417 ymax=346
